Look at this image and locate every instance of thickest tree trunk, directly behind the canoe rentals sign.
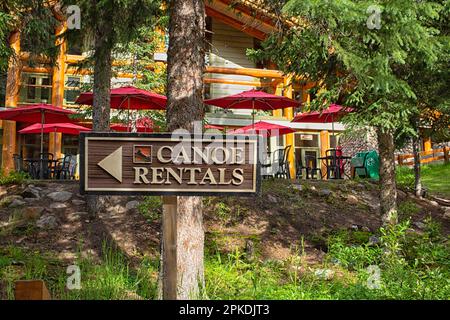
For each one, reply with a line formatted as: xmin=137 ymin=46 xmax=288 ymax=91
xmin=161 ymin=0 xmax=205 ymax=299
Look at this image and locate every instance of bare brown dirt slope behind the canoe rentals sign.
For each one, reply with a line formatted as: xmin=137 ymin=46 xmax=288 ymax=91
xmin=0 ymin=180 xmax=450 ymax=263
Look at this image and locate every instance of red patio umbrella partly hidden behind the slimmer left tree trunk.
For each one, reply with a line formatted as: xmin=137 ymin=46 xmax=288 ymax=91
xmin=75 ymin=86 xmax=167 ymax=132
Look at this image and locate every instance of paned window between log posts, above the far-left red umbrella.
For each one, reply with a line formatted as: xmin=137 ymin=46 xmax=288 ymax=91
xmin=19 ymin=73 xmax=52 ymax=104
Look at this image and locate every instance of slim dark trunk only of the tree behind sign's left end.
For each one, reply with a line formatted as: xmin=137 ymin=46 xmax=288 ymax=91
xmin=86 ymin=10 xmax=113 ymax=218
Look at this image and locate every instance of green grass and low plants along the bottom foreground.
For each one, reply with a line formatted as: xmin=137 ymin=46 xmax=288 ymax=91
xmin=0 ymin=220 xmax=450 ymax=300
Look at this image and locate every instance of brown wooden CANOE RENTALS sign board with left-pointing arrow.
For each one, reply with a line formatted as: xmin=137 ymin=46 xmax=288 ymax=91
xmin=80 ymin=133 xmax=260 ymax=195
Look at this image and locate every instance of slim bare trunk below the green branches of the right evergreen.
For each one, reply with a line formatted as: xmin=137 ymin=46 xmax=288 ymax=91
xmin=377 ymin=128 xmax=397 ymax=225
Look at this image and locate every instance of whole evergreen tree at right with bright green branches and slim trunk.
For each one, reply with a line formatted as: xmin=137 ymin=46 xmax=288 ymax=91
xmin=253 ymin=0 xmax=441 ymax=224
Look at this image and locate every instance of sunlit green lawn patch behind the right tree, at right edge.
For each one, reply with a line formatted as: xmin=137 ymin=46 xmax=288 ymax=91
xmin=397 ymin=163 xmax=450 ymax=199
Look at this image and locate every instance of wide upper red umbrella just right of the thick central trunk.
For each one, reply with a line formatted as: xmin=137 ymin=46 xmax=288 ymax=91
xmin=204 ymin=89 xmax=300 ymax=125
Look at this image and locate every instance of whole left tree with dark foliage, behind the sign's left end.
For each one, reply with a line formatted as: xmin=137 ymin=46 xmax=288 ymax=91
xmin=64 ymin=0 xmax=161 ymax=215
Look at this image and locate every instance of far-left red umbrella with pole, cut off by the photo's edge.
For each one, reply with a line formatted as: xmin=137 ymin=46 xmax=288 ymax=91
xmin=0 ymin=103 xmax=75 ymax=179
